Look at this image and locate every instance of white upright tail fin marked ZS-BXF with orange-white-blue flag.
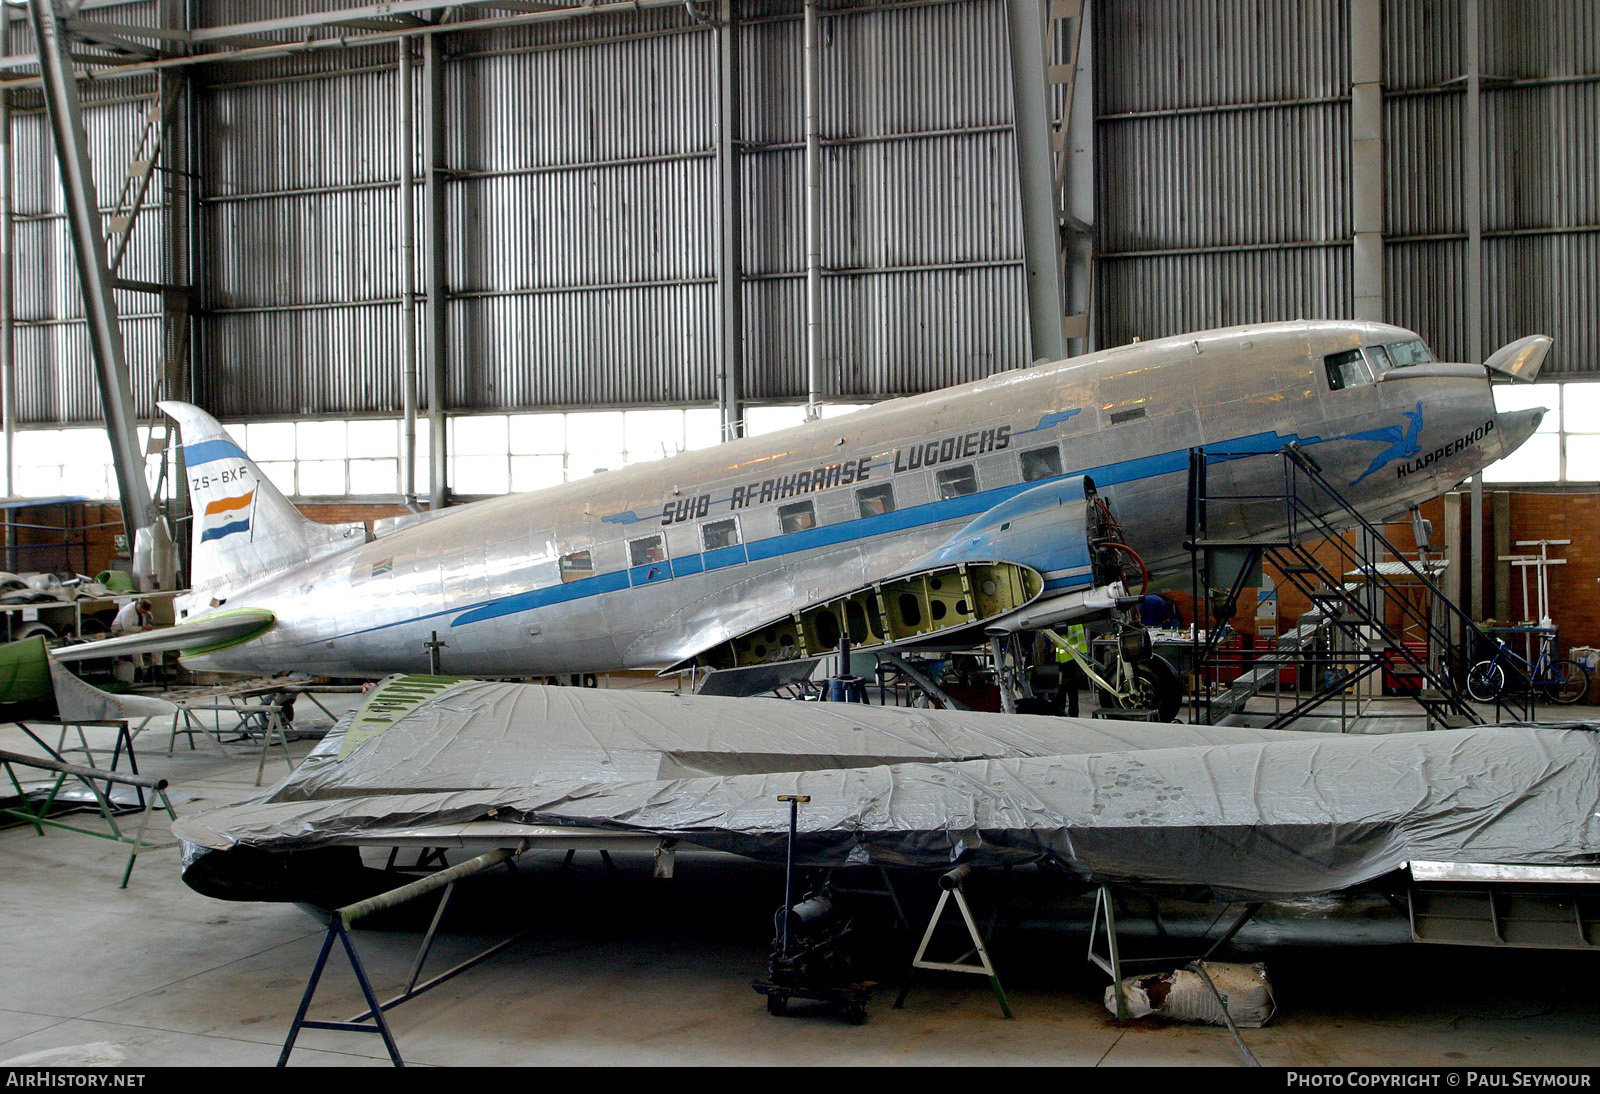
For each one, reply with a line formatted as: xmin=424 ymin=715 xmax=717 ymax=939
xmin=160 ymin=401 xmax=366 ymax=609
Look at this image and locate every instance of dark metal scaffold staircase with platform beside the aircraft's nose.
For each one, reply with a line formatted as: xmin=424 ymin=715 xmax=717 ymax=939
xmin=1187 ymin=445 xmax=1482 ymax=729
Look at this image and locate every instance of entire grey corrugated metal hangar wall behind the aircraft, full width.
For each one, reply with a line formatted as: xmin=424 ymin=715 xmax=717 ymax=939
xmin=13 ymin=0 xmax=1600 ymax=422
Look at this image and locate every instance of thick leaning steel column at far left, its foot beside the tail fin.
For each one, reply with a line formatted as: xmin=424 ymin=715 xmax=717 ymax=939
xmin=27 ymin=0 xmax=155 ymax=544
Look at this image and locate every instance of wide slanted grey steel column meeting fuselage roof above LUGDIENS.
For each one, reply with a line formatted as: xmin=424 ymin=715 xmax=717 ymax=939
xmin=1006 ymin=0 xmax=1066 ymax=361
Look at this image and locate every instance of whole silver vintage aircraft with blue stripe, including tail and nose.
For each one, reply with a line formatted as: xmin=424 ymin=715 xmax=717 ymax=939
xmin=58 ymin=321 xmax=1550 ymax=710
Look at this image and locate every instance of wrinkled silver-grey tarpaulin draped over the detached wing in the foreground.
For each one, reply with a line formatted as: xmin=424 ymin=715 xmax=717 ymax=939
xmin=174 ymin=678 xmax=1600 ymax=896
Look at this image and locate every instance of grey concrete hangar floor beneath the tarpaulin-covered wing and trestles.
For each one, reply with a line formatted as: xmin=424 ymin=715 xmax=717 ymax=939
xmin=0 ymin=687 xmax=1600 ymax=1067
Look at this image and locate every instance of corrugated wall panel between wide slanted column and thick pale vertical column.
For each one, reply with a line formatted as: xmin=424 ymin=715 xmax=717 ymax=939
xmin=1091 ymin=0 xmax=1352 ymax=345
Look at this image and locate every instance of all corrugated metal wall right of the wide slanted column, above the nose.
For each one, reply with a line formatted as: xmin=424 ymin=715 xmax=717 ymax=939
xmin=1093 ymin=0 xmax=1600 ymax=379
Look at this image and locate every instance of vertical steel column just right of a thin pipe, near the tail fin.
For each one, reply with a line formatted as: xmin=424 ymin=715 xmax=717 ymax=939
xmin=422 ymin=35 xmax=450 ymax=509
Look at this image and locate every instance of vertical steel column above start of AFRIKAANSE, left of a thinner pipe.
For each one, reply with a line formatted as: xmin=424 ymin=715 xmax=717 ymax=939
xmin=717 ymin=0 xmax=744 ymax=441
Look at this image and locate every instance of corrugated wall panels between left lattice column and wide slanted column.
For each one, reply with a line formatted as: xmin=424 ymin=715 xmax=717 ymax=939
xmin=187 ymin=0 xmax=1027 ymax=416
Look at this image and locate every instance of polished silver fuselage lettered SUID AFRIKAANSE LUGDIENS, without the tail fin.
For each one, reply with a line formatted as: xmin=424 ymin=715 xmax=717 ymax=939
xmin=190 ymin=321 xmax=1536 ymax=675
